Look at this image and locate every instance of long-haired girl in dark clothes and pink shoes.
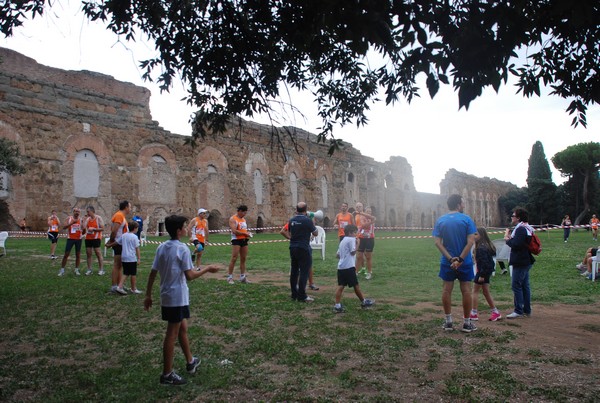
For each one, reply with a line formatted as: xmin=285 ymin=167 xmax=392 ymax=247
xmin=471 ymin=227 xmax=502 ymax=322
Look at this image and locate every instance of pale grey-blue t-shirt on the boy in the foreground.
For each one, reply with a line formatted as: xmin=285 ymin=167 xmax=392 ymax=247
xmin=152 ymin=239 xmax=194 ymax=307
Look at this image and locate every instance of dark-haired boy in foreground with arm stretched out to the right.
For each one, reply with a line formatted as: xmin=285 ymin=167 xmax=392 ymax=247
xmin=144 ymin=215 xmax=219 ymax=385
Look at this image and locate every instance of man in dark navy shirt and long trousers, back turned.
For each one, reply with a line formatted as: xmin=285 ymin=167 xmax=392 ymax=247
xmin=288 ymin=202 xmax=318 ymax=302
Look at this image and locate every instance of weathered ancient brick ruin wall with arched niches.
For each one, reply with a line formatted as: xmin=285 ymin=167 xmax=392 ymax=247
xmin=0 ymin=48 xmax=512 ymax=231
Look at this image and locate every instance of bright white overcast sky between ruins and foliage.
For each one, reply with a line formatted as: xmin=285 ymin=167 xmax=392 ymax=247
xmin=0 ymin=0 xmax=600 ymax=193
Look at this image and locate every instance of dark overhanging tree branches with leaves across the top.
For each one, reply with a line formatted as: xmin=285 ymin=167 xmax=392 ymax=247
xmin=0 ymin=0 xmax=600 ymax=152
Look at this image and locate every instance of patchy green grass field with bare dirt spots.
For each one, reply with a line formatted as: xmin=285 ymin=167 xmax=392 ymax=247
xmin=0 ymin=227 xmax=600 ymax=402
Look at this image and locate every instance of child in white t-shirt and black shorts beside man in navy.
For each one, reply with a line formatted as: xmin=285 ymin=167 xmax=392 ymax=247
xmin=333 ymin=224 xmax=375 ymax=313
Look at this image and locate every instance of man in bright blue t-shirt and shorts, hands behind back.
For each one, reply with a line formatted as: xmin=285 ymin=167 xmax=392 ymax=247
xmin=432 ymin=194 xmax=477 ymax=333
